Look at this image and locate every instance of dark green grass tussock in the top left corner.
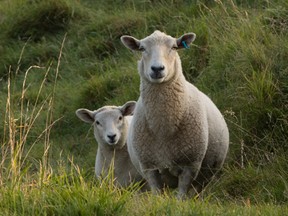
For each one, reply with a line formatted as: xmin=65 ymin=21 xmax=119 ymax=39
xmin=7 ymin=0 xmax=82 ymax=41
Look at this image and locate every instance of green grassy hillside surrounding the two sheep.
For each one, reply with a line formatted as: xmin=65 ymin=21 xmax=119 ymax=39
xmin=0 ymin=0 xmax=288 ymax=215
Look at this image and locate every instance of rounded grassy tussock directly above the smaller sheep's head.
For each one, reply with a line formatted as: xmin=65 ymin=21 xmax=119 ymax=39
xmin=78 ymin=57 xmax=139 ymax=109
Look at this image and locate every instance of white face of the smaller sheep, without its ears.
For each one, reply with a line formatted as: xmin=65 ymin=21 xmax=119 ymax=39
xmin=94 ymin=109 xmax=124 ymax=145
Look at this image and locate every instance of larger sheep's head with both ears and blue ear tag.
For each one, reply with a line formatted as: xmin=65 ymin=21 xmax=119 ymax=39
xmin=121 ymin=31 xmax=196 ymax=83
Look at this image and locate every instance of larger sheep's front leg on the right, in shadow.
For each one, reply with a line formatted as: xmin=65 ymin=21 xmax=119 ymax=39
xmin=177 ymin=163 xmax=201 ymax=199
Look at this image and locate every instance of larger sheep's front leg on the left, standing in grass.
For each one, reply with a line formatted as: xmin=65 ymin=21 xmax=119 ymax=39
xmin=144 ymin=169 xmax=163 ymax=194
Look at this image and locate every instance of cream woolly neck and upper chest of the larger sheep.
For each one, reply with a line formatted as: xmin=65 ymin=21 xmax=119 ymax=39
xmin=141 ymin=73 xmax=187 ymax=137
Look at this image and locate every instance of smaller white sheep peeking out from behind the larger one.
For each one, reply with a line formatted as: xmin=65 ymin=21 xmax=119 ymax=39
xmin=76 ymin=101 xmax=143 ymax=187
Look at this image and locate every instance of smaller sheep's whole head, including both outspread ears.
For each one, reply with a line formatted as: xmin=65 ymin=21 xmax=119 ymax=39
xmin=76 ymin=101 xmax=136 ymax=148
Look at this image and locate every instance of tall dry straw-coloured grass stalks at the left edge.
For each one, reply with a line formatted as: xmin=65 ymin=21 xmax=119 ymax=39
xmin=0 ymin=34 xmax=65 ymax=183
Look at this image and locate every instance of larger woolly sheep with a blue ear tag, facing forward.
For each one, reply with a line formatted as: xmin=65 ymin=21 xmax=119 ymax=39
xmin=121 ymin=31 xmax=229 ymax=199
